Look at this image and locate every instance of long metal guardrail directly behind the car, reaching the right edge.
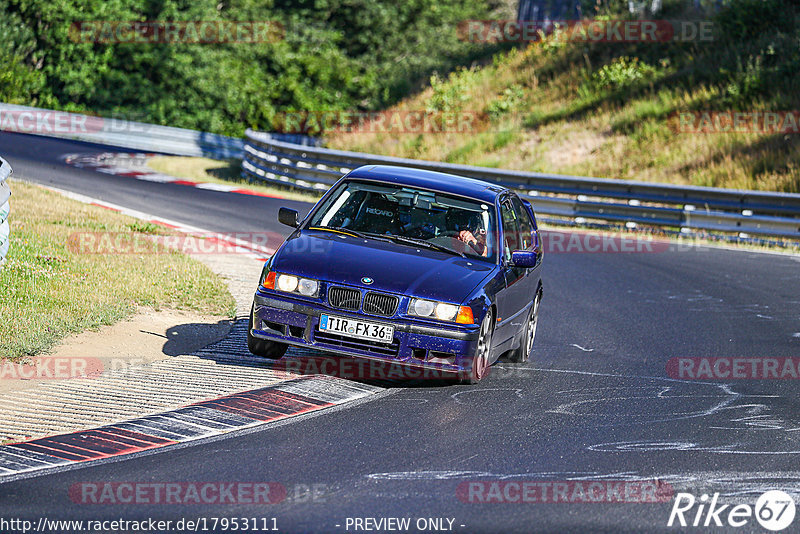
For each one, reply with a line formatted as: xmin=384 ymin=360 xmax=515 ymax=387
xmin=242 ymin=130 xmax=800 ymax=240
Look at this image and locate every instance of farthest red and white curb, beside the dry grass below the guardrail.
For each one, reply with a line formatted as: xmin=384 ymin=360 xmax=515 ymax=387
xmin=62 ymin=152 xmax=290 ymax=202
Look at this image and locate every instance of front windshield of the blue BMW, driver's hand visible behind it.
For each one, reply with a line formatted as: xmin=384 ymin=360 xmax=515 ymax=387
xmin=307 ymin=182 xmax=497 ymax=262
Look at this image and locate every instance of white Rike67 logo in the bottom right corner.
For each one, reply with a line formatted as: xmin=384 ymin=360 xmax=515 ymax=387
xmin=667 ymin=490 xmax=795 ymax=532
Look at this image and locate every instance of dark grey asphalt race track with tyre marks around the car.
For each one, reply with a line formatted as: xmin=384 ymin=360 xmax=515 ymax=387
xmin=0 ymin=133 xmax=800 ymax=532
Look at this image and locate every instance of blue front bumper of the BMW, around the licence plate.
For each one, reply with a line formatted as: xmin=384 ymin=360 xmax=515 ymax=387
xmin=251 ymin=291 xmax=479 ymax=377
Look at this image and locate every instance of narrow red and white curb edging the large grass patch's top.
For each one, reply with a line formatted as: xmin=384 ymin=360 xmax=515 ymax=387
xmin=41 ymin=186 xmax=283 ymax=262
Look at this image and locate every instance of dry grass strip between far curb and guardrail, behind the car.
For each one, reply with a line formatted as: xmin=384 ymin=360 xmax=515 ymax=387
xmin=147 ymin=156 xmax=322 ymax=202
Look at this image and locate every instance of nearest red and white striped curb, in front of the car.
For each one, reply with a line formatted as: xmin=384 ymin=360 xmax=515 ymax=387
xmin=0 ymin=376 xmax=384 ymax=483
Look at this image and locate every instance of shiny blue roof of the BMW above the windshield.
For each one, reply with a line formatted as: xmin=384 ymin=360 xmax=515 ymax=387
xmin=347 ymin=165 xmax=506 ymax=203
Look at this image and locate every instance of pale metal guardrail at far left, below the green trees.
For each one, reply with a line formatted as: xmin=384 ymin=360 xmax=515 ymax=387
xmin=0 ymin=103 xmax=243 ymax=159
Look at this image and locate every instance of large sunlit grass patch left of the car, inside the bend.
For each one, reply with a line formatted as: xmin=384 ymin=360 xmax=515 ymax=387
xmin=0 ymin=181 xmax=235 ymax=360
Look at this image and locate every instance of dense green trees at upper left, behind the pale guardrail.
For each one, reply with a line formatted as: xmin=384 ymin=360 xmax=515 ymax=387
xmin=0 ymin=0 xmax=490 ymax=135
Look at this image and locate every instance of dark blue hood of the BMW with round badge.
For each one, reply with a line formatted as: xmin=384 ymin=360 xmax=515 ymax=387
xmin=272 ymin=230 xmax=495 ymax=303
